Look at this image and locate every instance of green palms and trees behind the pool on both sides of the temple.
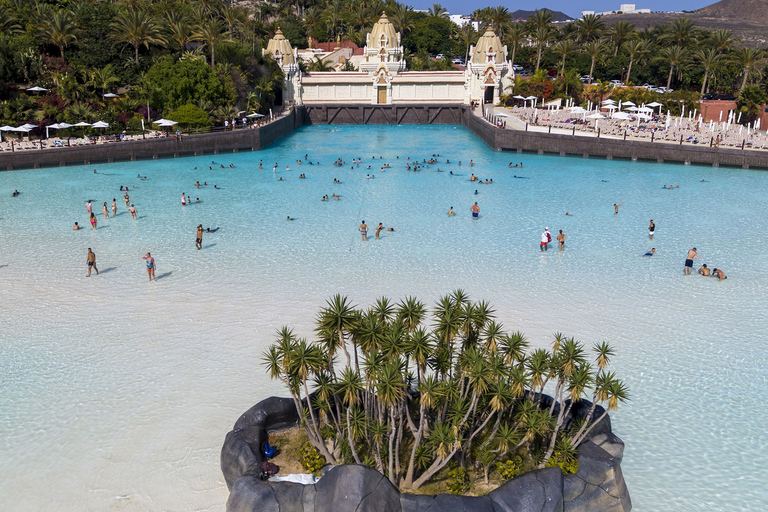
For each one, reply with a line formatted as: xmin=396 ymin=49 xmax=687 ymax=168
xmin=0 ymin=0 xmax=766 ymax=130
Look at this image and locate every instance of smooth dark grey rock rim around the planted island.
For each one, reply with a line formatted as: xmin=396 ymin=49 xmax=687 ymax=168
xmin=221 ymin=396 xmax=632 ymax=512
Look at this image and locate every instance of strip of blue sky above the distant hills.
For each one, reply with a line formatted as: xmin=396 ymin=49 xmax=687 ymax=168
xmin=406 ymin=0 xmax=717 ymax=18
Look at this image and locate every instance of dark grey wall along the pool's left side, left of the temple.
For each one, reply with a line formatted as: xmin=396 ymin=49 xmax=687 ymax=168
xmin=0 ymin=110 xmax=300 ymax=171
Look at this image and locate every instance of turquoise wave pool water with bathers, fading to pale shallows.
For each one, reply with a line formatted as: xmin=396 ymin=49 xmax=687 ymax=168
xmin=0 ymin=126 xmax=768 ymax=512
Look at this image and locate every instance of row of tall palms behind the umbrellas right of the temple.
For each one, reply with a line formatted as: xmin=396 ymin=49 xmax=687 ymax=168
xmin=474 ymin=11 xmax=768 ymax=95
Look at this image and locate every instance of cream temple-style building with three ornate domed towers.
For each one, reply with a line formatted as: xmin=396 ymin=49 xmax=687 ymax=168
xmin=263 ymin=13 xmax=514 ymax=105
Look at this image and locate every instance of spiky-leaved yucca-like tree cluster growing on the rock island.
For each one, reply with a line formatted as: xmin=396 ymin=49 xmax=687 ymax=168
xmin=264 ymin=290 xmax=628 ymax=489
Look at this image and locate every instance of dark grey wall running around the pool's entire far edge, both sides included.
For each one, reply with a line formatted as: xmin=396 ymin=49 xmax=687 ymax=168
xmin=0 ymin=104 xmax=768 ymax=170
